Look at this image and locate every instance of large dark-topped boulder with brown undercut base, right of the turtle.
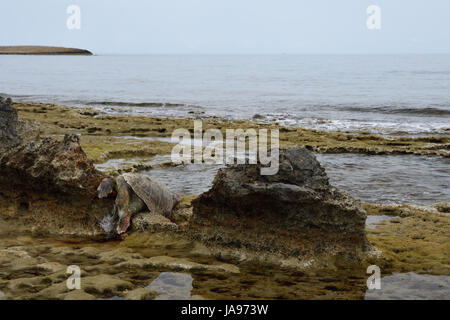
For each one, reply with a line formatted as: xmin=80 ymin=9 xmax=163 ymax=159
xmin=190 ymin=148 xmax=369 ymax=264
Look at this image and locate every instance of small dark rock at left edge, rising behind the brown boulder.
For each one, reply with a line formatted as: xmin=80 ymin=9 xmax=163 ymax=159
xmin=0 ymin=97 xmax=21 ymax=152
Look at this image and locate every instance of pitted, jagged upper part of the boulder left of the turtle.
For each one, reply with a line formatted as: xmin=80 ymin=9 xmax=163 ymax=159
xmin=0 ymin=134 xmax=105 ymax=197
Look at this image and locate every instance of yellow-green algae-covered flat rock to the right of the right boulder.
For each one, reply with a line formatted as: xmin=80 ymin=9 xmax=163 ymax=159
xmin=364 ymin=203 xmax=450 ymax=276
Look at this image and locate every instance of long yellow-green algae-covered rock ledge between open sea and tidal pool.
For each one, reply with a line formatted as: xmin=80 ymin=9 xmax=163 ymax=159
xmin=14 ymin=102 xmax=450 ymax=163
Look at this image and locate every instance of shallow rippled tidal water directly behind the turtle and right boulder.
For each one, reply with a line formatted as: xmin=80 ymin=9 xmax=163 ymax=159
xmin=147 ymin=153 xmax=450 ymax=205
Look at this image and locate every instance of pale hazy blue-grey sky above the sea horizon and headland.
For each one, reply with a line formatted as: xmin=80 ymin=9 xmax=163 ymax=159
xmin=0 ymin=0 xmax=450 ymax=54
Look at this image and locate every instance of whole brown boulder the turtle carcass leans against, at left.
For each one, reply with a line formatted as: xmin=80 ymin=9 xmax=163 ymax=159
xmin=0 ymin=134 xmax=113 ymax=235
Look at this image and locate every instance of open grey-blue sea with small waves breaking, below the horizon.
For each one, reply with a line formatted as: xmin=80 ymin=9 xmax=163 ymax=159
xmin=0 ymin=55 xmax=450 ymax=135
